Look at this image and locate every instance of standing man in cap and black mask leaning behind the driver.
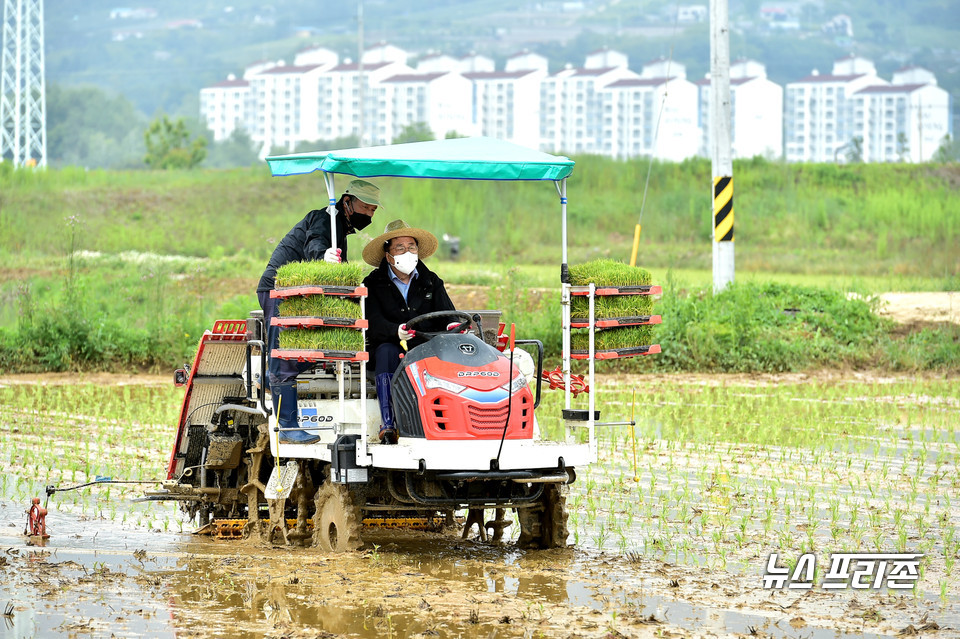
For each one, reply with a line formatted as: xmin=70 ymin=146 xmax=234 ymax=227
xmin=257 ymin=180 xmax=381 ymax=444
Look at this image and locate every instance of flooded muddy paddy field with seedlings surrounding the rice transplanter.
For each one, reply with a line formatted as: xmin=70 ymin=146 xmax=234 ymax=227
xmin=0 ymin=373 xmax=960 ymax=638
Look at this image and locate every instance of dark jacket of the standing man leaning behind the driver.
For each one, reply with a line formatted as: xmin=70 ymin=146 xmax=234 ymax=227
xmin=257 ymin=203 xmax=354 ymax=292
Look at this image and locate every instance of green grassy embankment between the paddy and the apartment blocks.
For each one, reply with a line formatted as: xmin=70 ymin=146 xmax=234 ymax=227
xmin=0 ymin=157 xmax=960 ymax=371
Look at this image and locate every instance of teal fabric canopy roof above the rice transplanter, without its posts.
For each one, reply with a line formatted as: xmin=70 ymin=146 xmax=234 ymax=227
xmin=267 ymin=137 xmax=574 ymax=180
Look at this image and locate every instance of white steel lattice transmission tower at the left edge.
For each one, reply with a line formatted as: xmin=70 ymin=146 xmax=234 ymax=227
xmin=0 ymin=0 xmax=47 ymax=166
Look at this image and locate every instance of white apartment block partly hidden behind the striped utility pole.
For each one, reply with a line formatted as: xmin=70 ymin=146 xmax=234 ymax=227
xmin=697 ymin=60 xmax=783 ymax=158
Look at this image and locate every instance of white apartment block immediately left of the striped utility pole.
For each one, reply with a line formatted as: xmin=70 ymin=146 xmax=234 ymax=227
xmin=600 ymin=60 xmax=699 ymax=161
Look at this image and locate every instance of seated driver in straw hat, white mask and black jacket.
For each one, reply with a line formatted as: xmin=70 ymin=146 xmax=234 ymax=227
xmin=363 ymin=220 xmax=456 ymax=444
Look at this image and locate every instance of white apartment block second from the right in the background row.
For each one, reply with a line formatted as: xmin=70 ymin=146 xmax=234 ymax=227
xmin=783 ymin=55 xmax=886 ymax=162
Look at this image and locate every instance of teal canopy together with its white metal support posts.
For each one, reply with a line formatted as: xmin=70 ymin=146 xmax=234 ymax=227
xmin=266 ymin=137 xmax=597 ymax=459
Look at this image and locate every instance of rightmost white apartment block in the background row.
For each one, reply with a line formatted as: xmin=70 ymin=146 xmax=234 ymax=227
xmin=853 ymin=67 xmax=951 ymax=162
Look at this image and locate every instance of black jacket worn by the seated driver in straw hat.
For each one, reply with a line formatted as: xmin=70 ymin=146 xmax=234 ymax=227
xmin=363 ymin=258 xmax=456 ymax=353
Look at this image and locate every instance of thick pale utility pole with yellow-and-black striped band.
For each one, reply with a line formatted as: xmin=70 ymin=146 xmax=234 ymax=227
xmin=710 ymin=0 xmax=734 ymax=293
